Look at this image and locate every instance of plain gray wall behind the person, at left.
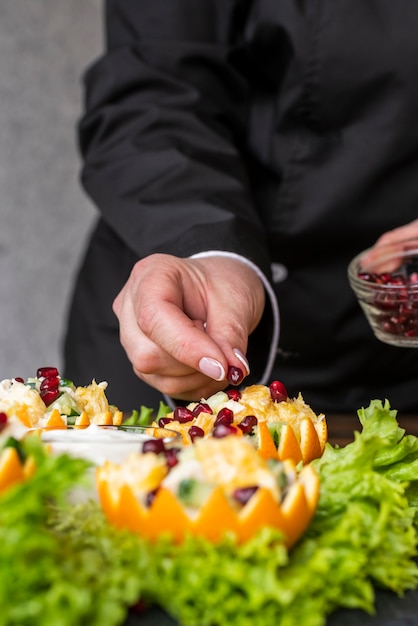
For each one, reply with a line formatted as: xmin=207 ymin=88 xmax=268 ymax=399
xmin=0 ymin=0 xmax=103 ymax=379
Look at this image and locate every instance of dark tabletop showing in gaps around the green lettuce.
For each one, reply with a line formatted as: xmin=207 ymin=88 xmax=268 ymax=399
xmin=124 ymin=413 xmax=418 ymax=626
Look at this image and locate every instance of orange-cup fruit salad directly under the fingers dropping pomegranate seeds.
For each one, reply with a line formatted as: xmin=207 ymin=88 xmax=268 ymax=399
xmin=153 ymin=381 xmax=327 ymax=463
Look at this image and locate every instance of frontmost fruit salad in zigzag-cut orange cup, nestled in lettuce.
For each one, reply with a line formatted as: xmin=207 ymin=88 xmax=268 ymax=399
xmin=96 ymin=435 xmax=319 ymax=547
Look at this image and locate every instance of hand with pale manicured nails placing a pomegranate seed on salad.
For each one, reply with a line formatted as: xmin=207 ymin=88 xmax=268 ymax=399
xmin=113 ymin=254 xmax=265 ymax=400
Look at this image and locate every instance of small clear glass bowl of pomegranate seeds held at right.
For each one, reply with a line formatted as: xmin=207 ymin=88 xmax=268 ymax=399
xmin=348 ymin=238 xmax=418 ymax=348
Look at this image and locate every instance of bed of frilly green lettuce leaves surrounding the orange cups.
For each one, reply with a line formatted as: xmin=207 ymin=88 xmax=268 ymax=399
xmin=0 ymin=401 xmax=418 ymax=626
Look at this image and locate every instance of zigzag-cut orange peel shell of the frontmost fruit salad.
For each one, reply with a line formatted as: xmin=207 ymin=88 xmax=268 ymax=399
xmin=96 ymin=462 xmax=319 ymax=548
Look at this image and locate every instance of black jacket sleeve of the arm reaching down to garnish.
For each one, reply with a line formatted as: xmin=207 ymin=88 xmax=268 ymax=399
xmin=79 ymin=0 xmax=269 ymax=274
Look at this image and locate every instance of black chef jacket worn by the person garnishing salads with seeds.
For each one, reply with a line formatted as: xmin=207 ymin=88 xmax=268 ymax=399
xmin=66 ymin=0 xmax=418 ymax=412
